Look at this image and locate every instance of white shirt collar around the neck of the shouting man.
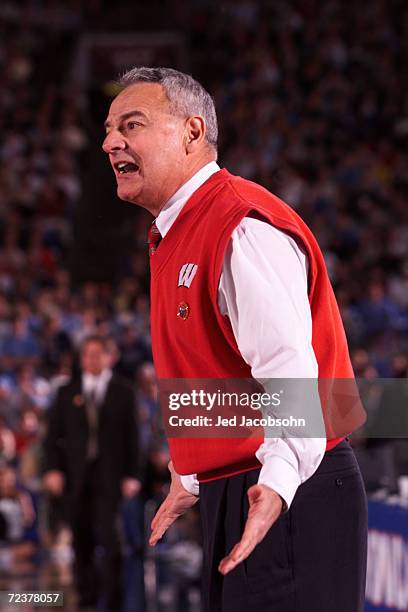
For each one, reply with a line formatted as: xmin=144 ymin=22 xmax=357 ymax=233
xmin=156 ymin=161 xmax=220 ymax=238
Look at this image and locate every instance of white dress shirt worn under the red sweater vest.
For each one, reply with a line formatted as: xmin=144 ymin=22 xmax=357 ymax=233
xmin=156 ymin=162 xmax=326 ymax=507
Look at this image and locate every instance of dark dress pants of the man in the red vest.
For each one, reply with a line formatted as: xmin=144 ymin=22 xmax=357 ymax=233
xmin=200 ymin=441 xmax=367 ymax=612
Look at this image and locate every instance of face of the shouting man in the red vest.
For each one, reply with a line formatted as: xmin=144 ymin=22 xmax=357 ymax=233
xmin=103 ymin=83 xmax=187 ymax=214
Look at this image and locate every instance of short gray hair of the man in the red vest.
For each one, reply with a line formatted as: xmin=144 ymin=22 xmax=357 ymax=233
xmin=118 ymin=66 xmax=218 ymax=150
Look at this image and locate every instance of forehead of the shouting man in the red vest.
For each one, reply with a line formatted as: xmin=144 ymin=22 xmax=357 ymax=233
xmin=108 ymin=83 xmax=168 ymax=121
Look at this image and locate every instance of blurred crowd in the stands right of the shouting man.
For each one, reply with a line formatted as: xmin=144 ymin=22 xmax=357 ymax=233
xmin=196 ymin=0 xmax=408 ymax=377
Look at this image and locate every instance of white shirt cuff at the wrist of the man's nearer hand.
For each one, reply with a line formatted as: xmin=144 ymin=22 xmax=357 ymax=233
xmin=255 ymin=449 xmax=302 ymax=509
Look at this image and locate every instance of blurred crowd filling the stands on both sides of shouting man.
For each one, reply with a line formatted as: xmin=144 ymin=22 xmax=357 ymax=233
xmin=0 ymin=0 xmax=408 ymax=608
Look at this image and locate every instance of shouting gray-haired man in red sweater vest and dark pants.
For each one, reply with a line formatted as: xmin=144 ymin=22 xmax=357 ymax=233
xmin=103 ymin=68 xmax=366 ymax=612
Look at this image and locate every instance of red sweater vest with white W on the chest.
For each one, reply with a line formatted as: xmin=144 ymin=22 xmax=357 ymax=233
xmin=151 ymin=170 xmax=360 ymax=481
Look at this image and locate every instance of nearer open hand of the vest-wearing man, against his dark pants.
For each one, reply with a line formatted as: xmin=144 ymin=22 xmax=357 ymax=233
xmin=218 ymin=484 xmax=283 ymax=576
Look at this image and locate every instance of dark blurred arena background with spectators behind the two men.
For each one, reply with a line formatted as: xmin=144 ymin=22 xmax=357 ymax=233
xmin=0 ymin=0 xmax=408 ymax=612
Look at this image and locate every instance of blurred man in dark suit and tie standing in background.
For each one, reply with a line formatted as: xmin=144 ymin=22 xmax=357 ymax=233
xmin=44 ymin=336 xmax=140 ymax=610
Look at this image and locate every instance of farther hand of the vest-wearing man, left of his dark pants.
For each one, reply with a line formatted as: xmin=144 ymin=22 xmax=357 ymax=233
xmin=149 ymin=461 xmax=198 ymax=546
